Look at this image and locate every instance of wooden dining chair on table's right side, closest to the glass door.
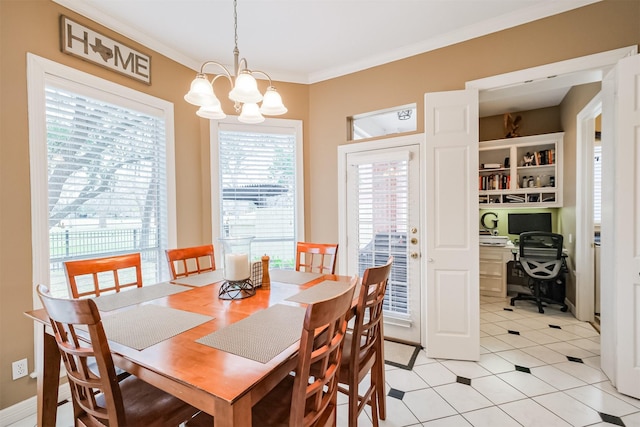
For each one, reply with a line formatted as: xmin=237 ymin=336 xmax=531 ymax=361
xmin=338 ymin=257 xmax=393 ymax=427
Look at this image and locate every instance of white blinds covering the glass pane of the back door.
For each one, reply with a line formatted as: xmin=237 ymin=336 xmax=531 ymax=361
xmin=353 ymin=157 xmax=410 ymax=315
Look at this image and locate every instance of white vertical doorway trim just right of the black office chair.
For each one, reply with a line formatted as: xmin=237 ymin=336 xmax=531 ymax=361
xmin=575 ymin=93 xmax=602 ymax=322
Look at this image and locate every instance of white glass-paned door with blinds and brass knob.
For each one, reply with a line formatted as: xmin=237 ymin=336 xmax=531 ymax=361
xmin=343 ymin=135 xmax=422 ymax=343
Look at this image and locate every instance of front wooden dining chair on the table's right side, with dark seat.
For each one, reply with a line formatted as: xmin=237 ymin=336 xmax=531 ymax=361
xmin=187 ymin=276 xmax=358 ymax=427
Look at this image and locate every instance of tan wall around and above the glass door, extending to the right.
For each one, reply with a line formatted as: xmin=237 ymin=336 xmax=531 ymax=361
xmin=305 ymin=0 xmax=640 ymax=241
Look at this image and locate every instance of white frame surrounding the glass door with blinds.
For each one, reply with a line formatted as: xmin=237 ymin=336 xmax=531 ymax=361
xmin=337 ymin=133 xmax=426 ymax=345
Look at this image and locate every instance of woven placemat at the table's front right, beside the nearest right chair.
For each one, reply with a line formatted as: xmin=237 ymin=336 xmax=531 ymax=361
xmin=196 ymin=304 xmax=305 ymax=363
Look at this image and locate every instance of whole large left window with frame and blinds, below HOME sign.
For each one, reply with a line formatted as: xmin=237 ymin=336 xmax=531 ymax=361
xmin=30 ymin=55 xmax=175 ymax=297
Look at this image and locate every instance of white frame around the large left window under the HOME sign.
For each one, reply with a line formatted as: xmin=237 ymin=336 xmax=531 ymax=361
xmin=27 ymin=53 xmax=177 ymax=309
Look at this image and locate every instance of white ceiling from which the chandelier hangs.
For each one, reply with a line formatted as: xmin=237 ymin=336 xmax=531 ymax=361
xmin=54 ymin=0 xmax=599 ymax=115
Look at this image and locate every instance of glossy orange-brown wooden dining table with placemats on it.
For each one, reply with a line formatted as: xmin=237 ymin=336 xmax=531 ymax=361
xmin=25 ymin=272 xmax=355 ymax=427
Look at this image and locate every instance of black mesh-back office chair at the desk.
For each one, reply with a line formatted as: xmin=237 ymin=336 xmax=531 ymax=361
xmin=511 ymin=231 xmax=568 ymax=313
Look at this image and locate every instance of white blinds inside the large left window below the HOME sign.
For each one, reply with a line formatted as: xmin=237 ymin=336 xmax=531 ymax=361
xmin=45 ymin=85 xmax=167 ymax=295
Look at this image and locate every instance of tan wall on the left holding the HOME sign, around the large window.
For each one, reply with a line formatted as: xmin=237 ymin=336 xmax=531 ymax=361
xmin=0 ymin=0 xmax=309 ymax=409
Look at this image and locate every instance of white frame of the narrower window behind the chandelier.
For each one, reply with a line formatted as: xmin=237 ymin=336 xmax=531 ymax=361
xmin=209 ymin=116 xmax=304 ymax=265
